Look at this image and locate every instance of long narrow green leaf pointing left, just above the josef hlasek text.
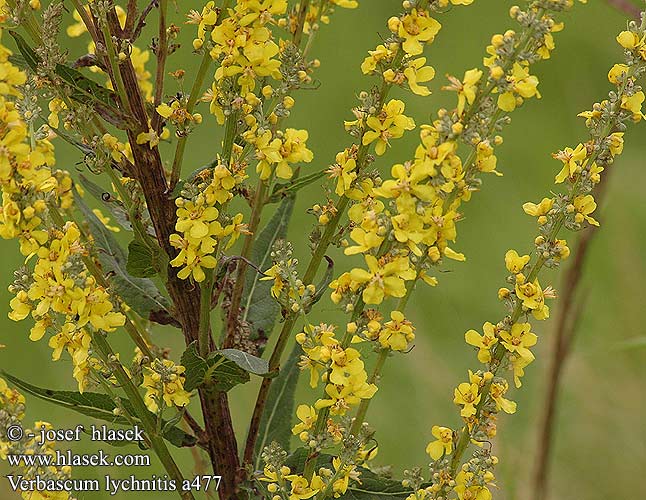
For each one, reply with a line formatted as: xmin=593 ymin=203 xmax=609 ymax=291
xmin=0 ymin=370 xmax=197 ymax=448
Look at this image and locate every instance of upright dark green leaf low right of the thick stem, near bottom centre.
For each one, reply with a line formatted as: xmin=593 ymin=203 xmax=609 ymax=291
xmin=256 ymin=344 xmax=303 ymax=469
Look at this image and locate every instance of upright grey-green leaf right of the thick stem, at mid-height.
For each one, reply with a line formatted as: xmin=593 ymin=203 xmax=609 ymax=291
xmin=242 ymin=197 xmax=294 ymax=353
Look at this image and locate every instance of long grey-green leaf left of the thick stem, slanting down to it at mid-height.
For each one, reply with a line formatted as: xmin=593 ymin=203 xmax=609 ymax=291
xmin=74 ymin=189 xmax=170 ymax=318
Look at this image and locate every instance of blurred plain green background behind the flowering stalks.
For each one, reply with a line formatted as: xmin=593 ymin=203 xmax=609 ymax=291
xmin=0 ymin=0 xmax=646 ymax=500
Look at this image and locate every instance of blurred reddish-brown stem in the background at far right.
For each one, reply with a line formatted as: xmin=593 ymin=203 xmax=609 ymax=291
xmin=531 ymin=170 xmax=612 ymax=500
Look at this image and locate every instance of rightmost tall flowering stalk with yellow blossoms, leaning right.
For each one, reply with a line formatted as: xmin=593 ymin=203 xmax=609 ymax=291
xmin=410 ymin=15 xmax=646 ymax=499
